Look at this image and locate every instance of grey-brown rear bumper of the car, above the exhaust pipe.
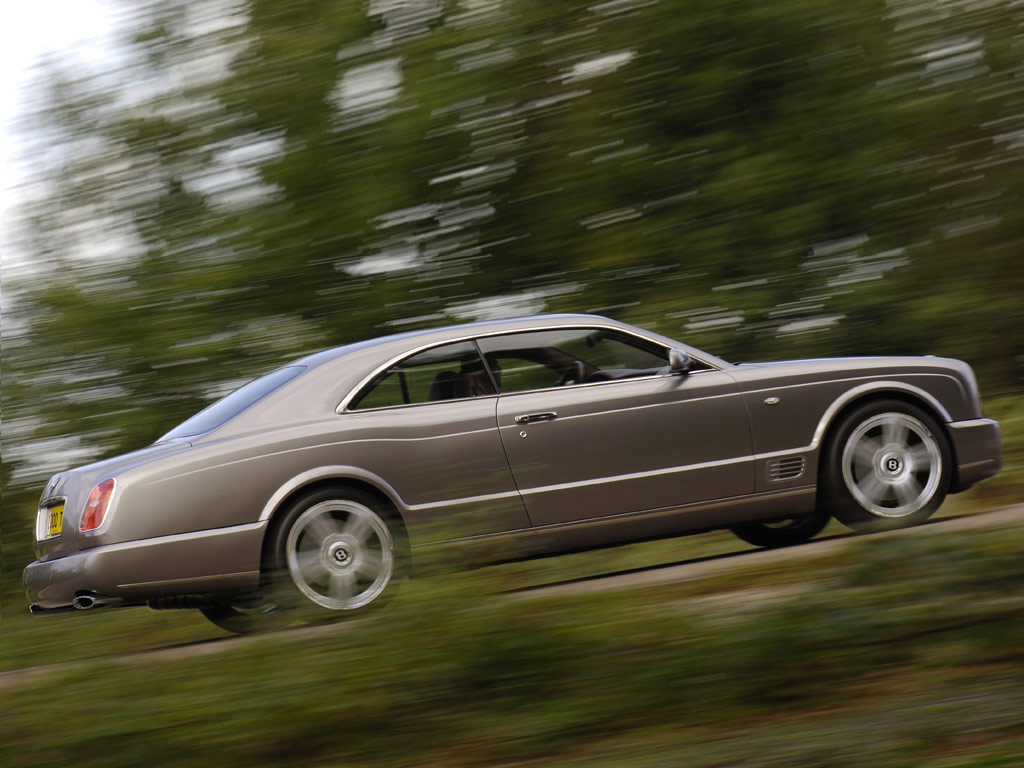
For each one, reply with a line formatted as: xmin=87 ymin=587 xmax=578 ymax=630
xmin=24 ymin=521 xmax=266 ymax=613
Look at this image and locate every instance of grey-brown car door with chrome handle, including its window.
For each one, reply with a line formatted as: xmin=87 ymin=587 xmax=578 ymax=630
xmin=478 ymin=329 xmax=754 ymax=525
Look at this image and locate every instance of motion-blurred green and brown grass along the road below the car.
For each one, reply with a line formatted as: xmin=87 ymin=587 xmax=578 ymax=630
xmin=0 ymin=518 xmax=1024 ymax=768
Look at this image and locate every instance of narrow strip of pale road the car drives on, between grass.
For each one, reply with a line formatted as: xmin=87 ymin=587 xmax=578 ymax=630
xmin=0 ymin=504 xmax=1024 ymax=689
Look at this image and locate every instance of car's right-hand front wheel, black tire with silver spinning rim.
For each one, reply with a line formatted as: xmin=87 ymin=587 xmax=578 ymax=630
xmin=818 ymin=400 xmax=952 ymax=530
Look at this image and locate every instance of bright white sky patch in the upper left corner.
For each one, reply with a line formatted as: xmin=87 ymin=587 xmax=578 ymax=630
xmin=0 ymin=0 xmax=117 ymax=258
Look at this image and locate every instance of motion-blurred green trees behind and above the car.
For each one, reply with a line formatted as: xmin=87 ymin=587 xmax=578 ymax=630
xmin=0 ymin=0 xmax=1024 ymax=573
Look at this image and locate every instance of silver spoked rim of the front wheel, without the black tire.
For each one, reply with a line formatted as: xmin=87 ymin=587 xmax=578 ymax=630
xmin=842 ymin=413 xmax=942 ymax=517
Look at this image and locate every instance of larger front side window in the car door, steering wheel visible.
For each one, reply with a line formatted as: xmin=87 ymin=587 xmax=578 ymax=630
xmin=478 ymin=329 xmax=668 ymax=392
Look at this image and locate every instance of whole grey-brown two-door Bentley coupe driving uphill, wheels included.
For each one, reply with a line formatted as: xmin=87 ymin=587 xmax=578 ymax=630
xmin=25 ymin=314 xmax=1000 ymax=630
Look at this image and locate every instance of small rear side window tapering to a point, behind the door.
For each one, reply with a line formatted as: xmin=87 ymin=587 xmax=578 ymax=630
xmin=348 ymin=341 xmax=495 ymax=411
